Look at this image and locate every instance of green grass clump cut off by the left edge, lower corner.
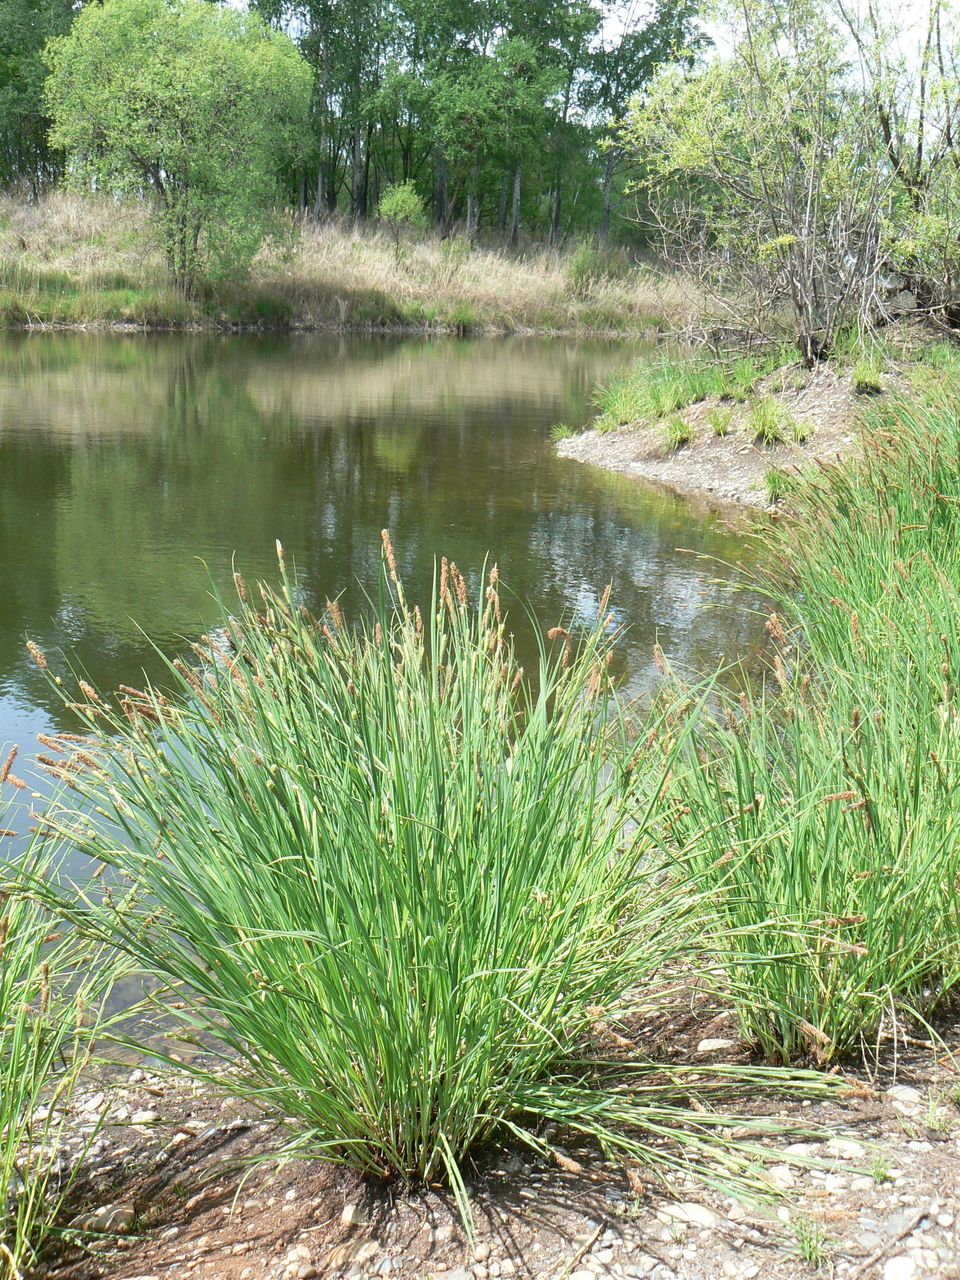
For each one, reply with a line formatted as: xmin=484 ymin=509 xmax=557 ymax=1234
xmin=0 ymin=819 xmax=109 ymax=1280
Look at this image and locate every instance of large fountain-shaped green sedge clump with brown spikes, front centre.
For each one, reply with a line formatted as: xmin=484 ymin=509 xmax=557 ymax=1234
xmin=32 ymin=540 xmax=822 ymax=1213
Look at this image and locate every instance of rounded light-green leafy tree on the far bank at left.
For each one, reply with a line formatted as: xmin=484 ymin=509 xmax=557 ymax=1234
xmin=45 ymin=0 xmax=311 ymax=289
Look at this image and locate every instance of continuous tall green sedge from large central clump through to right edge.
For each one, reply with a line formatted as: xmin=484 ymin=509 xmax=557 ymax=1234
xmin=0 ymin=368 xmax=960 ymax=1259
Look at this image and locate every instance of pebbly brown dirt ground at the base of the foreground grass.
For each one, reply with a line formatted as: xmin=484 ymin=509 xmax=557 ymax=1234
xmin=41 ymin=989 xmax=960 ymax=1280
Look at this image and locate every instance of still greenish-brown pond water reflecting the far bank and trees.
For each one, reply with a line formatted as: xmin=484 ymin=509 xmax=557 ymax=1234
xmin=0 ymin=334 xmax=759 ymax=757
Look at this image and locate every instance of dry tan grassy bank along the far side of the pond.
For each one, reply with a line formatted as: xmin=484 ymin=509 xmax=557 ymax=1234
xmin=0 ymin=193 xmax=694 ymax=334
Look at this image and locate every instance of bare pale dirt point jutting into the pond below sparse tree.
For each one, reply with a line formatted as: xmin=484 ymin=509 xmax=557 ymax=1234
xmin=557 ymin=365 xmax=895 ymax=507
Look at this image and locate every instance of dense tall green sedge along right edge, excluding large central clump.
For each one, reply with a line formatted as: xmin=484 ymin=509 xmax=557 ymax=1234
xmin=664 ymin=370 xmax=960 ymax=1061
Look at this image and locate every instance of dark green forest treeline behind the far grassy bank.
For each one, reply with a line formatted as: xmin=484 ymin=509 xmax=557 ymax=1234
xmin=0 ymin=0 xmax=703 ymax=243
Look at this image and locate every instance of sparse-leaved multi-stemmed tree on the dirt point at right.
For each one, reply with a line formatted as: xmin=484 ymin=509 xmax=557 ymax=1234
xmin=632 ymin=0 xmax=891 ymax=362
